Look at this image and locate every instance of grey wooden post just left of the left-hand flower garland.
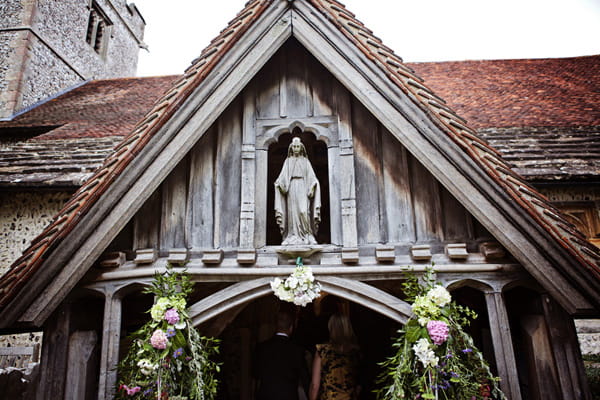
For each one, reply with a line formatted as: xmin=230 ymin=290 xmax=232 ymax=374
xmin=98 ymin=293 xmax=121 ymax=400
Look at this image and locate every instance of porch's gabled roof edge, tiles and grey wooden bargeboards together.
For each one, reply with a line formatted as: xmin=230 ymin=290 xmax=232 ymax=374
xmin=0 ymin=0 xmax=600 ymax=327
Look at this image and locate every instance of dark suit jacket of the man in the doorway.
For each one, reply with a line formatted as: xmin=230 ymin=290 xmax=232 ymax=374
xmin=254 ymin=335 xmax=309 ymax=400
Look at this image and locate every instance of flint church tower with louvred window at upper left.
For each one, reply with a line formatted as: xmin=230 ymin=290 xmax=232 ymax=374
xmin=0 ymin=0 xmax=145 ymax=119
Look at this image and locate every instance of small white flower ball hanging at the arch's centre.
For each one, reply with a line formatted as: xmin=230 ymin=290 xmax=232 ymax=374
xmin=271 ymin=257 xmax=321 ymax=307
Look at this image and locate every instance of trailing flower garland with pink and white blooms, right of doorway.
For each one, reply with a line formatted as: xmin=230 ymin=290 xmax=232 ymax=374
xmin=377 ymin=268 xmax=506 ymax=400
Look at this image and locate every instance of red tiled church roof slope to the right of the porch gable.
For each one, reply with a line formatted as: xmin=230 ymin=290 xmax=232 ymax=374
xmin=407 ymin=55 xmax=600 ymax=130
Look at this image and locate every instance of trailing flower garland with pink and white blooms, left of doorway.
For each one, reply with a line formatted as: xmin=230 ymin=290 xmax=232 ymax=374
xmin=115 ymin=266 xmax=219 ymax=400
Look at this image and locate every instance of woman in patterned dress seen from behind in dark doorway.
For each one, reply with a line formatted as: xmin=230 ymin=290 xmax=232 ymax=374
xmin=309 ymin=314 xmax=360 ymax=400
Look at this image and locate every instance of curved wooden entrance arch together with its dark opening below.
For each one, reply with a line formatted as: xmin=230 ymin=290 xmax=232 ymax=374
xmin=189 ymin=276 xmax=411 ymax=400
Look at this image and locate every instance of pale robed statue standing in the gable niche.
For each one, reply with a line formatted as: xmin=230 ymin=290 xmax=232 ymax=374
xmin=275 ymin=137 xmax=321 ymax=246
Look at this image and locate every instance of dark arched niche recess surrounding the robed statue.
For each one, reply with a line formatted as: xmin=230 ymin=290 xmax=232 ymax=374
xmin=267 ymin=128 xmax=331 ymax=245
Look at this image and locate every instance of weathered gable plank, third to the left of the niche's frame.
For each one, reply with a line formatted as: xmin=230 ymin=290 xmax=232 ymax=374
xmin=160 ymin=157 xmax=189 ymax=250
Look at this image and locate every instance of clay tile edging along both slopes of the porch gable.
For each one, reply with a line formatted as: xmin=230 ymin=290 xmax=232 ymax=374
xmin=0 ymin=0 xmax=600 ymax=318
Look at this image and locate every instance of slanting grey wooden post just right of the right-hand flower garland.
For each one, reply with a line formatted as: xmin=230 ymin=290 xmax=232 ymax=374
xmin=485 ymin=292 xmax=521 ymax=400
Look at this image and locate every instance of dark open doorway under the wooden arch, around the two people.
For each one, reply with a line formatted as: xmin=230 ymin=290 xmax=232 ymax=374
xmin=209 ymin=295 xmax=401 ymax=400
